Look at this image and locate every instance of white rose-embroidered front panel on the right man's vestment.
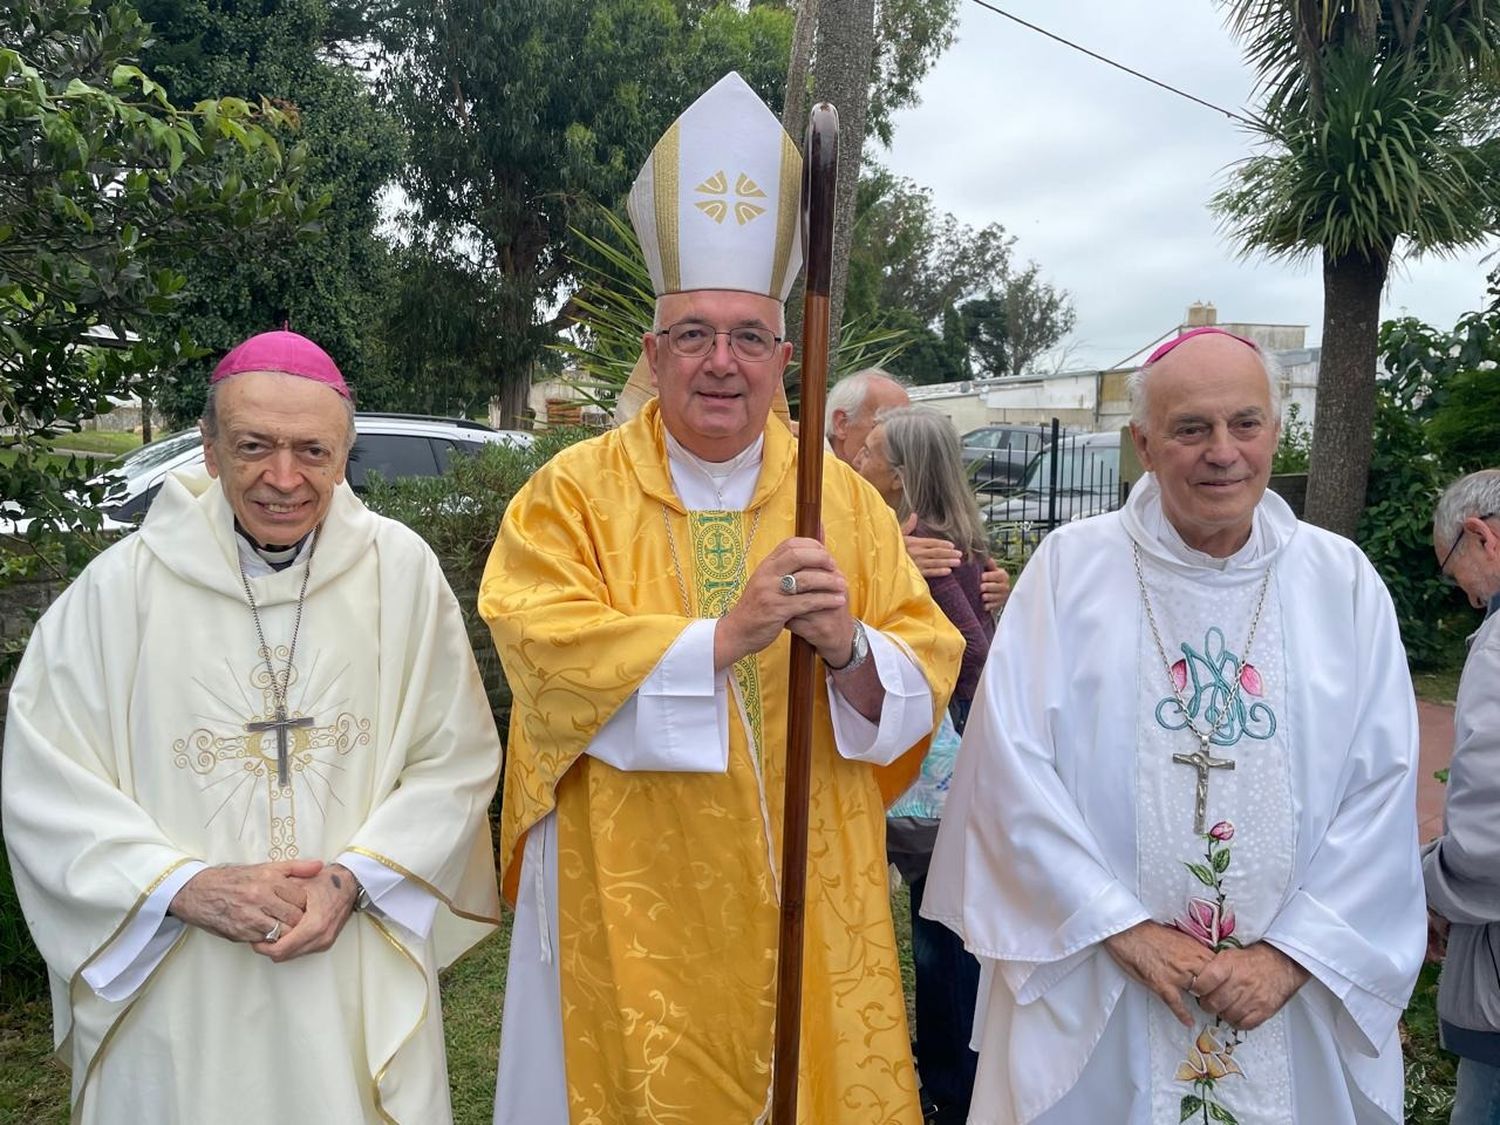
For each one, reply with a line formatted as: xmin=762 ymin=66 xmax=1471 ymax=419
xmin=1136 ymin=557 xmax=1296 ymax=1125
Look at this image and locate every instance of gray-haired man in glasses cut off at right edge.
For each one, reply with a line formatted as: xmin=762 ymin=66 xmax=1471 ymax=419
xmin=1422 ymin=470 xmax=1500 ymax=1125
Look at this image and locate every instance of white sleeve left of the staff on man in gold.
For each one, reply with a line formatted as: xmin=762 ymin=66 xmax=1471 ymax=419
xmin=587 ymin=618 xmax=731 ymax=774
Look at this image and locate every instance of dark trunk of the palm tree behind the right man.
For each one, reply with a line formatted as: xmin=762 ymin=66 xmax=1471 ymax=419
xmin=1305 ymin=254 xmax=1389 ymax=539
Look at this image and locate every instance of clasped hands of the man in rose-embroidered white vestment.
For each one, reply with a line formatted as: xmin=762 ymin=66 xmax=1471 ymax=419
xmin=1104 ymin=921 xmax=1308 ymax=1031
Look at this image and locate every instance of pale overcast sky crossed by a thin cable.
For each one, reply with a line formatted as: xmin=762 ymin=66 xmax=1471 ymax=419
xmin=876 ymin=0 xmax=1500 ymax=368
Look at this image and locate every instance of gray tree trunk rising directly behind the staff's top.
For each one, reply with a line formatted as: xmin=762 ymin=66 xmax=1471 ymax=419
xmin=800 ymin=0 xmax=875 ymax=354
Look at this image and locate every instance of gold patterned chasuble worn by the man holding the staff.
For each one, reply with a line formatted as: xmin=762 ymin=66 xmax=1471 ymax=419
xmin=480 ymin=402 xmax=963 ymax=1125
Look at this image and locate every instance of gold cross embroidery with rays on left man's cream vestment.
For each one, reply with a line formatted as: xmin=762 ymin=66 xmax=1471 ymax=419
xmin=173 ymin=645 xmax=371 ymax=863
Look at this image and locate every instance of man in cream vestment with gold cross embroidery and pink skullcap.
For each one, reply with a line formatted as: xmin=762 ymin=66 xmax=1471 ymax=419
xmin=0 ymin=332 xmax=500 ymax=1125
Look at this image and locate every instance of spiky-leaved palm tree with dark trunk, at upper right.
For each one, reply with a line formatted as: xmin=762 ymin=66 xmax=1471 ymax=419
xmin=1214 ymin=0 xmax=1500 ymax=536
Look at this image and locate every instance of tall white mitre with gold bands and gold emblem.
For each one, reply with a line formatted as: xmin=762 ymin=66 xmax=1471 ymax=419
xmin=629 ymin=71 xmax=803 ymax=302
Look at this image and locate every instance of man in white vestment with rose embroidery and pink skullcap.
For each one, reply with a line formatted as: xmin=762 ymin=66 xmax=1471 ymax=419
xmin=923 ymin=329 xmax=1427 ymax=1125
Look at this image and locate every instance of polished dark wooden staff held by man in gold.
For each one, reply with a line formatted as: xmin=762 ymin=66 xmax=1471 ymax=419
xmin=771 ymin=102 xmax=839 ymax=1125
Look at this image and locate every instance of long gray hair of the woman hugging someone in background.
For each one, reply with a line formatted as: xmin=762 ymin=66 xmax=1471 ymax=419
xmin=875 ymin=407 xmax=989 ymax=558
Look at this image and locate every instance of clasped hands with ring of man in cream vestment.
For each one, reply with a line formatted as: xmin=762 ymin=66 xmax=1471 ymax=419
xmin=167 ymin=860 xmax=359 ymax=962
